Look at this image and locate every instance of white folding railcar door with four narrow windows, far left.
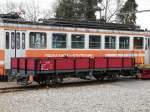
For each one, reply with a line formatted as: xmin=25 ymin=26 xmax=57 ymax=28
xmin=5 ymin=30 xmax=26 ymax=72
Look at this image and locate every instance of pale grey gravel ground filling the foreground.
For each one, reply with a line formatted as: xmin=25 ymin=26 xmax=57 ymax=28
xmin=0 ymin=79 xmax=150 ymax=112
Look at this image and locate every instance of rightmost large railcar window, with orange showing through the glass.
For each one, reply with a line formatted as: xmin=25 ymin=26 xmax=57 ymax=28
xmin=134 ymin=37 xmax=144 ymax=49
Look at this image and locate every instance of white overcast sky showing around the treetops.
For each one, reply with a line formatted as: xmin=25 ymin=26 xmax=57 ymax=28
xmin=0 ymin=0 xmax=150 ymax=29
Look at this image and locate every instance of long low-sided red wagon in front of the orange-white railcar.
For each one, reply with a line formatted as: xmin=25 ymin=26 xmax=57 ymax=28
xmin=11 ymin=57 xmax=135 ymax=84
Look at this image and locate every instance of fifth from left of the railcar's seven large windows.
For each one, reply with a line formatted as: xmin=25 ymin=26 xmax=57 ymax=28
xmin=105 ymin=36 xmax=116 ymax=49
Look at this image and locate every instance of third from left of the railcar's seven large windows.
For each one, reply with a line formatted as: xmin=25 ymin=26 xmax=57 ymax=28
xmin=71 ymin=34 xmax=85 ymax=49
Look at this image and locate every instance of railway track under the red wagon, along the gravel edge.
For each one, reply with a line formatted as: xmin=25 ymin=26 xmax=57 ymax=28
xmin=0 ymin=78 xmax=134 ymax=94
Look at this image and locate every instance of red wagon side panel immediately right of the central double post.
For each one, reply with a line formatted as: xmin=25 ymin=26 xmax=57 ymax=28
xmin=94 ymin=57 xmax=107 ymax=69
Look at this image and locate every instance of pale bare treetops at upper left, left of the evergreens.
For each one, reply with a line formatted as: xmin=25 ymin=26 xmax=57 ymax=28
xmin=0 ymin=0 xmax=54 ymax=21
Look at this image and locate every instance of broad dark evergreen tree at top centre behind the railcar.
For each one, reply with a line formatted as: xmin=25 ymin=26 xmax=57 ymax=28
xmin=56 ymin=0 xmax=97 ymax=21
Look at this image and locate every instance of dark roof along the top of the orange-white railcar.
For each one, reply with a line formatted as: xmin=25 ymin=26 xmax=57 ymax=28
xmin=1 ymin=19 xmax=144 ymax=31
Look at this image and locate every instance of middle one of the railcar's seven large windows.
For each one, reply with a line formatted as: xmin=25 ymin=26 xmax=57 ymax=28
xmin=89 ymin=35 xmax=101 ymax=49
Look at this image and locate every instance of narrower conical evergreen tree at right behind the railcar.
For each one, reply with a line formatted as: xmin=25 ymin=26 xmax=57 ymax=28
xmin=118 ymin=0 xmax=138 ymax=24
